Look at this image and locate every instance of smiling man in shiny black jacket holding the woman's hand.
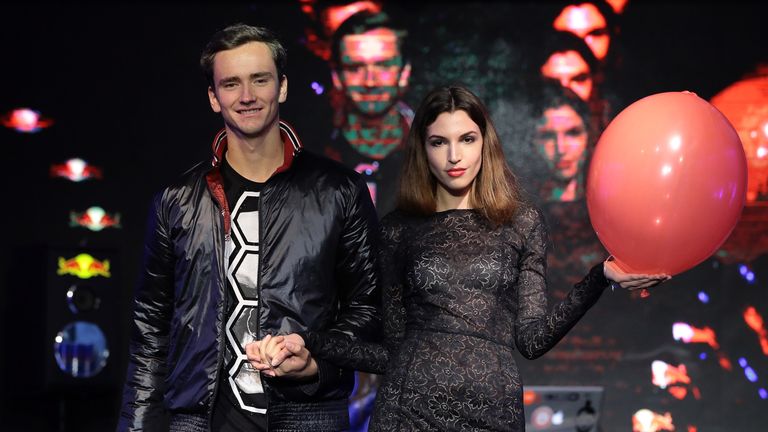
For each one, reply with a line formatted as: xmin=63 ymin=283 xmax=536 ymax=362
xmin=118 ymin=24 xmax=379 ymax=432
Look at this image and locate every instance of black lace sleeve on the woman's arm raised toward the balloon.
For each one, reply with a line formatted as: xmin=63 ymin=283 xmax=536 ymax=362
xmin=515 ymin=210 xmax=608 ymax=359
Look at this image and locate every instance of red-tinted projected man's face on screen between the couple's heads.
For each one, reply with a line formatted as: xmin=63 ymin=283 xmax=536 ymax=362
xmin=333 ymin=28 xmax=410 ymax=116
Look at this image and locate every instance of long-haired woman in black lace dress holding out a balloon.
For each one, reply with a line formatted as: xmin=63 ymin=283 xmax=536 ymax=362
xmin=249 ymin=86 xmax=667 ymax=431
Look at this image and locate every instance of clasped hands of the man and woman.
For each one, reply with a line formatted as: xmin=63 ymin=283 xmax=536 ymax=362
xmin=245 ymin=333 xmax=317 ymax=378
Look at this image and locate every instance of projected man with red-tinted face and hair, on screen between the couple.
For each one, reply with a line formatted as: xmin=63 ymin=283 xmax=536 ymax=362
xmin=325 ymin=9 xmax=413 ymax=215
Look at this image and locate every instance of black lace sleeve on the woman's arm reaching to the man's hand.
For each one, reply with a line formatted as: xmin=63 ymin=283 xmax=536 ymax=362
xmin=301 ymin=214 xmax=405 ymax=374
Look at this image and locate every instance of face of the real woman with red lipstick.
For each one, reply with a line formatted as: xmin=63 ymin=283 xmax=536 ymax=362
xmin=424 ymin=110 xmax=483 ymax=207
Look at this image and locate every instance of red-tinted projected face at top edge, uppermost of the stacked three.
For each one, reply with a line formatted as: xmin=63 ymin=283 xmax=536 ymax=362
xmin=553 ymin=3 xmax=611 ymax=60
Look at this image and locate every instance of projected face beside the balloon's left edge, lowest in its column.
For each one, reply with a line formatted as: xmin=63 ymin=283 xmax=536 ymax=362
xmin=535 ymin=105 xmax=587 ymax=180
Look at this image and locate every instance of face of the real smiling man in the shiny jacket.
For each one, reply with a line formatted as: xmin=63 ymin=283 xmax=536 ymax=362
xmin=208 ymin=42 xmax=288 ymax=138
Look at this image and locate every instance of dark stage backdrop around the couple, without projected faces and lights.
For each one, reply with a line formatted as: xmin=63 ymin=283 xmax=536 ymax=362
xmin=0 ymin=1 xmax=768 ymax=432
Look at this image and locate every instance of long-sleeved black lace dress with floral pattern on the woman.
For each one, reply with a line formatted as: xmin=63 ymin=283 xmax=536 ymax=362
xmin=303 ymin=208 xmax=608 ymax=431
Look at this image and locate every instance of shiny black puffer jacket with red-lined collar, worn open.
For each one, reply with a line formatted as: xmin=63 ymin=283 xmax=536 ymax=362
xmin=118 ymin=122 xmax=380 ymax=431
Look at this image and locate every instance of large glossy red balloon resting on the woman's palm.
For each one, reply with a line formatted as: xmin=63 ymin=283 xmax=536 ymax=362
xmin=587 ymin=92 xmax=747 ymax=275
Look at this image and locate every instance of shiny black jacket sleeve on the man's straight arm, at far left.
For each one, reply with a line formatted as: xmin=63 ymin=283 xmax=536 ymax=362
xmin=117 ymin=194 xmax=174 ymax=431
